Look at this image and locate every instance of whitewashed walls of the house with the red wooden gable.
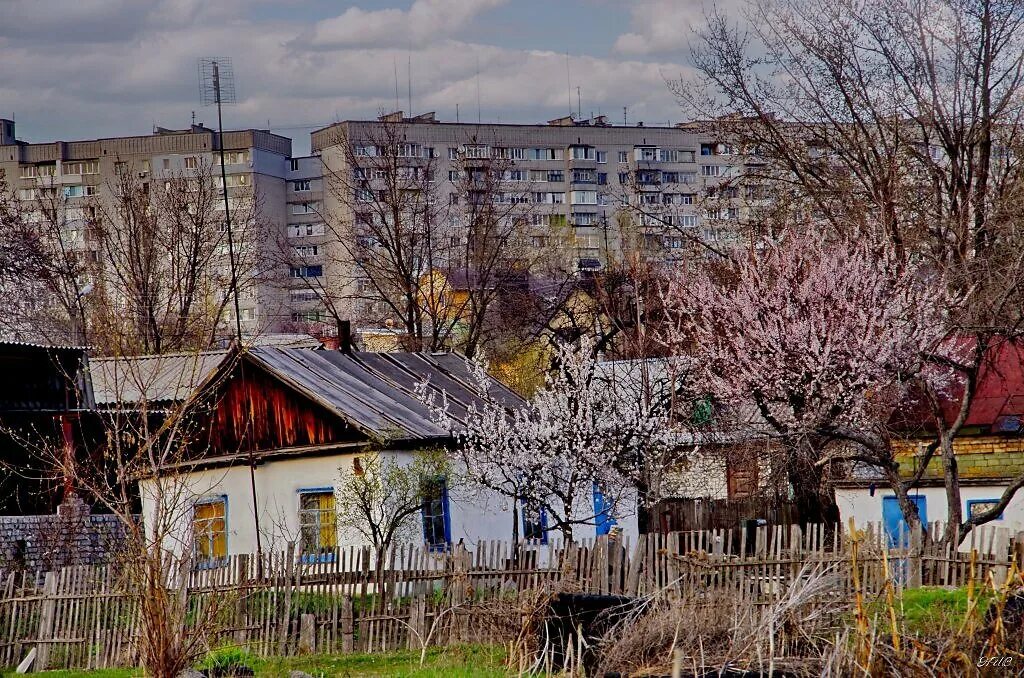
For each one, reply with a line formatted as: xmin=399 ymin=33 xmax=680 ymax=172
xmin=140 ymin=452 xmax=637 ymax=555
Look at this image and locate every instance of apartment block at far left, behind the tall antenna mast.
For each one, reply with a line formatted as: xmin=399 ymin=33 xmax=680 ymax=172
xmin=0 ymin=120 xmax=292 ymax=342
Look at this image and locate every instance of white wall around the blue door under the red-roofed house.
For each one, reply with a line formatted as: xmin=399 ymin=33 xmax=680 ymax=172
xmin=836 ymin=484 xmax=1024 ymax=550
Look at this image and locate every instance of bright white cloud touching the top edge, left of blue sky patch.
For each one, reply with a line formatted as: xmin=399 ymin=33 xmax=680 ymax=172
xmin=299 ymin=0 xmax=506 ymax=49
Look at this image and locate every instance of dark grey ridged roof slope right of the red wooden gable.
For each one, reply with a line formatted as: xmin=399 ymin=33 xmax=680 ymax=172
xmin=246 ymin=347 xmax=521 ymax=439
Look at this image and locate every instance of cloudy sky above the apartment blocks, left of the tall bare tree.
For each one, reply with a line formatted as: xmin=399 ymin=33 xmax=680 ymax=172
xmin=0 ymin=0 xmax=735 ymax=155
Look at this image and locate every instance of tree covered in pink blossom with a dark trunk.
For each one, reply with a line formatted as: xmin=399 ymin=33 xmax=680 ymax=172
xmin=665 ymin=230 xmax=949 ymax=522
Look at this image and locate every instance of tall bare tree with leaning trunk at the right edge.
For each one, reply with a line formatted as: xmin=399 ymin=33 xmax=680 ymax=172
xmin=676 ymin=0 xmax=1024 ymax=540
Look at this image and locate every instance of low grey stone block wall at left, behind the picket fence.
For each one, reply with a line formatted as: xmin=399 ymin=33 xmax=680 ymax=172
xmin=0 ymin=499 xmax=131 ymax=571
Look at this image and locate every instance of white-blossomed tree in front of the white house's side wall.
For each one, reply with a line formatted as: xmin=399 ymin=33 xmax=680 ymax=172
xmin=425 ymin=341 xmax=672 ymax=540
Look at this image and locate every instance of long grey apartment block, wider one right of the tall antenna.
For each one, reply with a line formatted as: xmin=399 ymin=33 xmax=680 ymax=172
xmin=296 ymin=113 xmax=743 ymax=331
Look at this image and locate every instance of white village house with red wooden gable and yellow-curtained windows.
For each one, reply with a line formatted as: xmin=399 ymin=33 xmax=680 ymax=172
xmin=93 ymin=347 xmax=635 ymax=562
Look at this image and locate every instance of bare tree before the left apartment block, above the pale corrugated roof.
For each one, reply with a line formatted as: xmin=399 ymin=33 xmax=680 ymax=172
xmin=95 ymin=157 xmax=264 ymax=353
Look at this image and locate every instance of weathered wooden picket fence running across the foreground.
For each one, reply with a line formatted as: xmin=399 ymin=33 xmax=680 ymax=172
xmin=0 ymin=525 xmax=1024 ymax=669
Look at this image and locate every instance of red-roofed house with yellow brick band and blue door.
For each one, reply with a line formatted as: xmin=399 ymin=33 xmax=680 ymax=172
xmin=836 ymin=341 xmax=1024 ymax=537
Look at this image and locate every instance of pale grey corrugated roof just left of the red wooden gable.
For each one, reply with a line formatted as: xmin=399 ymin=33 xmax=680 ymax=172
xmin=89 ymin=350 xmax=227 ymax=408
